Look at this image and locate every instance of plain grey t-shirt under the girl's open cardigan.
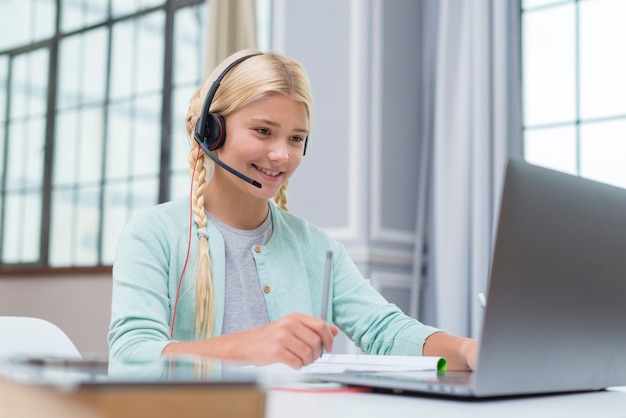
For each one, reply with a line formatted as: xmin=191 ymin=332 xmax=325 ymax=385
xmin=207 ymin=213 xmax=272 ymax=335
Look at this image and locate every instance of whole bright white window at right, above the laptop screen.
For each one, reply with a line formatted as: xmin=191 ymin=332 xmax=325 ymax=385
xmin=522 ymin=0 xmax=626 ymax=187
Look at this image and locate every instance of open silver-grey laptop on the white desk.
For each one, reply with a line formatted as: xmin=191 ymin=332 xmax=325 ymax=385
xmin=317 ymin=159 xmax=626 ymax=398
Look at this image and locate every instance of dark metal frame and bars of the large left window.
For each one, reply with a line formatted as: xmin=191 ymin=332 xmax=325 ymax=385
xmin=0 ymin=0 xmax=205 ymax=278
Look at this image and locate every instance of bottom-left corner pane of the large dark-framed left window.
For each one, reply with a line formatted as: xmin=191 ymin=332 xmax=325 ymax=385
xmin=2 ymin=192 xmax=41 ymax=263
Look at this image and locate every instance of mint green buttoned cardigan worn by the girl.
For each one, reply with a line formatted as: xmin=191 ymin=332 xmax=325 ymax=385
xmin=108 ymin=198 xmax=438 ymax=361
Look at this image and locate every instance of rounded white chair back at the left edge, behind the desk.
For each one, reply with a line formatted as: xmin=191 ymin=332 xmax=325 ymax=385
xmin=0 ymin=316 xmax=82 ymax=359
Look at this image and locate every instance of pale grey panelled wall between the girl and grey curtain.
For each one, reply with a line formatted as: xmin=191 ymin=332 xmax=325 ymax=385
xmin=273 ymin=0 xmax=422 ymax=313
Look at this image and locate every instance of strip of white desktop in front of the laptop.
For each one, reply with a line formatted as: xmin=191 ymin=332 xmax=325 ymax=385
xmin=265 ymin=388 xmax=626 ymax=418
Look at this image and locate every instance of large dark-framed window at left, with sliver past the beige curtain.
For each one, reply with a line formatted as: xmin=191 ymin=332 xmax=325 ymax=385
xmin=0 ymin=0 xmax=270 ymax=270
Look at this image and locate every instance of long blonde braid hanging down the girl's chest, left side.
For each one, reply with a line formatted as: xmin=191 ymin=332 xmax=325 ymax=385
xmin=189 ymin=148 xmax=215 ymax=338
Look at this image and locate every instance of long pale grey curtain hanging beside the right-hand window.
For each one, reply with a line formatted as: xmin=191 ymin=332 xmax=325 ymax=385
xmin=415 ymin=0 xmax=521 ymax=336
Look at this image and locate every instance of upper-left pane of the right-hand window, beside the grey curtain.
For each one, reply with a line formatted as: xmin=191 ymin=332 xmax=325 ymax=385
xmin=522 ymin=3 xmax=576 ymax=126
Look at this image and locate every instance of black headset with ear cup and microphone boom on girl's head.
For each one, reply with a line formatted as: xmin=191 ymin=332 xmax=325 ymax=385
xmin=193 ymin=54 xmax=263 ymax=189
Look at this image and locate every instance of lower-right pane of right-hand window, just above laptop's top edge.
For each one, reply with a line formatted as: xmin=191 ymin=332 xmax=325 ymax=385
xmin=580 ymin=120 xmax=626 ymax=187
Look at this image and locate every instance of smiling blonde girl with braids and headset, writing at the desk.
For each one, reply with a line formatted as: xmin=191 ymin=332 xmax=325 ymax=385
xmin=109 ymin=50 xmax=478 ymax=369
